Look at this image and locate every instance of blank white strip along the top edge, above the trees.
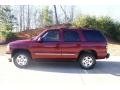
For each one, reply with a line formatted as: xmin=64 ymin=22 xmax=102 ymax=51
xmin=0 ymin=0 xmax=120 ymax=5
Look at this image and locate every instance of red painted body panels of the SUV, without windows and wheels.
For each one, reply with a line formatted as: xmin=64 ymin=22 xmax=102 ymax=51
xmin=7 ymin=29 xmax=107 ymax=60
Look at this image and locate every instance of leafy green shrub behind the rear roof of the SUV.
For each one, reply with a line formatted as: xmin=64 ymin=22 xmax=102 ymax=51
xmin=72 ymin=15 xmax=120 ymax=41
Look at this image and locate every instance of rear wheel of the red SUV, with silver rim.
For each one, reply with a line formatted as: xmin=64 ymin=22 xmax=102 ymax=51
xmin=79 ymin=53 xmax=96 ymax=70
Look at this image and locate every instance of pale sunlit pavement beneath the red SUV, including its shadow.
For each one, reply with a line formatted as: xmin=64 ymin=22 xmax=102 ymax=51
xmin=0 ymin=55 xmax=120 ymax=90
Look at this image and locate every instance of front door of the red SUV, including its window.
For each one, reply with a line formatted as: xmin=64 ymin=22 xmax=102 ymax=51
xmin=31 ymin=30 xmax=61 ymax=59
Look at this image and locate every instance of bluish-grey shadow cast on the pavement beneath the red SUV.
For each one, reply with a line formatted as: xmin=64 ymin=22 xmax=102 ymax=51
xmin=28 ymin=61 xmax=120 ymax=76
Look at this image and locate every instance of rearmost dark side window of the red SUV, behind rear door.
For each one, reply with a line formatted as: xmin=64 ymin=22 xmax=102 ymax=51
xmin=83 ymin=31 xmax=106 ymax=42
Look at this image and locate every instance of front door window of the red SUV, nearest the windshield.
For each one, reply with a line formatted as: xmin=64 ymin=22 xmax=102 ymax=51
xmin=42 ymin=30 xmax=59 ymax=42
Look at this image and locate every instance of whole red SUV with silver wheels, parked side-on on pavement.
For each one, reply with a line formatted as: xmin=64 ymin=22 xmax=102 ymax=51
xmin=7 ymin=28 xmax=109 ymax=69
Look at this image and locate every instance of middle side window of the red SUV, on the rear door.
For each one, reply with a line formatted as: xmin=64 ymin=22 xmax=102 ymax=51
xmin=64 ymin=30 xmax=80 ymax=42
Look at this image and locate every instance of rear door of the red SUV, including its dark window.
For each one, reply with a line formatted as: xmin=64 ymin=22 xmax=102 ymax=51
xmin=60 ymin=30 xmax=80 ymax=60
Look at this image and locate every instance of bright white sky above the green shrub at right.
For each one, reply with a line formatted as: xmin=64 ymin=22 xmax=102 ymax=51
xmin=76 ymin=4 xmax=120 ymax=21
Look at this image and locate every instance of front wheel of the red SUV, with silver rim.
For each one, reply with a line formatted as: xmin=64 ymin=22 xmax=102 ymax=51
xmin=13 ymin=52 xmax=31 ymax=68
